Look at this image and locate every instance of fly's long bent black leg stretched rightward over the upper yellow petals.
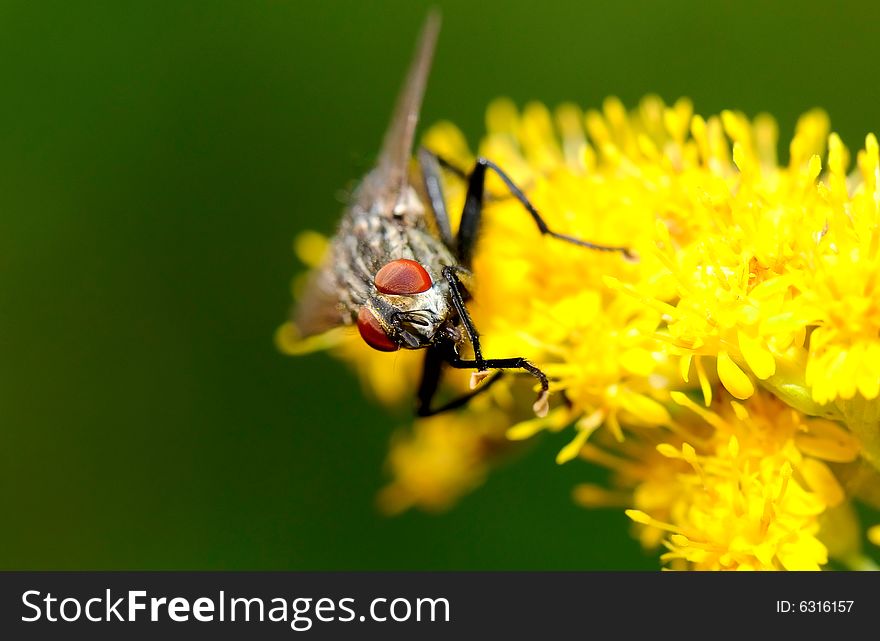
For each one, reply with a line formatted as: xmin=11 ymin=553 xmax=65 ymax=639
xmin=428 ymin=152 xmax=632 ymax=266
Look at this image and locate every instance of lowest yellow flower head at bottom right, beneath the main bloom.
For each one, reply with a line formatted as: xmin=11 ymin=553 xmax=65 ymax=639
xmin=612 ymin=384 xmax=858 ymax=570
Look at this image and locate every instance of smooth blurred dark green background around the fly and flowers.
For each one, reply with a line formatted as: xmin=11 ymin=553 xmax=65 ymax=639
xmin=0 ymin=0 xmax=880 ymax=569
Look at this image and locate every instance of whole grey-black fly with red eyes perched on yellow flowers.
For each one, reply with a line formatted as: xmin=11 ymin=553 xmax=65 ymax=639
xmin=293 ymin=13 xmax=628 ymax=416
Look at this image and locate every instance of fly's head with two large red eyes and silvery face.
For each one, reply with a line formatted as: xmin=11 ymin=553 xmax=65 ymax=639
xmin=357 ymin=258 xmax=457 ymax=352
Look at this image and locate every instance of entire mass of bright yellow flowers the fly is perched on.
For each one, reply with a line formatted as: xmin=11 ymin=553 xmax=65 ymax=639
xmin=279 ymin=96 xmax=880 ymax=569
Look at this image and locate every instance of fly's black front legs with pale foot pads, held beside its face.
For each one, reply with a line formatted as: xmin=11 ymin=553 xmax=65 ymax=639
xmin=443 ymin=266 xmax=550 ymax=416
